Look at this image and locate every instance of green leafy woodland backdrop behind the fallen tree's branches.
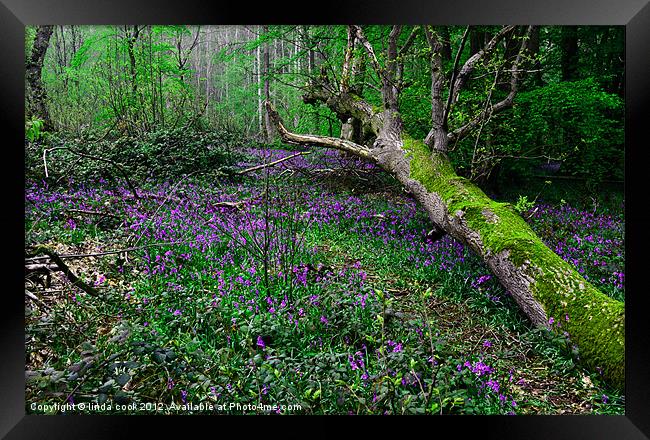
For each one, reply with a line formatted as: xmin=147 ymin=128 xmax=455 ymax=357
xmin=36 ymin=25 xmax=624 ymax=191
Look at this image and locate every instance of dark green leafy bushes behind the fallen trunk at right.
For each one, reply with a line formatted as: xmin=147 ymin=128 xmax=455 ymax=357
xmin=451 ymin=78 xmax=624 ymax=191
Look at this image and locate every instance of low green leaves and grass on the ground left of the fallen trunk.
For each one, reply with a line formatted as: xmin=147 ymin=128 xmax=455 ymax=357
xmin=26 ymin=171 xmax=624 ymax=414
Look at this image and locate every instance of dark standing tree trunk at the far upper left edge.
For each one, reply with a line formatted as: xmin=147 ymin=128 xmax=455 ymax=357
xmin=25 ymin=26 xmax=54 ymax=130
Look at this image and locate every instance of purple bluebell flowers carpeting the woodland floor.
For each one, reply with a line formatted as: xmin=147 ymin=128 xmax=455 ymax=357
xmin=25 ymin=149 xmax=624 ymax=408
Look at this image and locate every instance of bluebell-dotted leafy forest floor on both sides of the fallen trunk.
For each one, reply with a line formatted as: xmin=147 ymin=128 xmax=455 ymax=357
xmin=25 ymin=150 xmax=624 ymax=414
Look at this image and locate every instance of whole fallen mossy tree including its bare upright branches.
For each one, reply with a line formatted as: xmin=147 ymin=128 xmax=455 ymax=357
xmin=266 ymin=26 xmax=625 ymax=389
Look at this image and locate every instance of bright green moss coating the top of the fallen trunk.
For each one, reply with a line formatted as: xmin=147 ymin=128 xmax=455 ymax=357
xmin=403 ymin=138 xmax=625 ymax=389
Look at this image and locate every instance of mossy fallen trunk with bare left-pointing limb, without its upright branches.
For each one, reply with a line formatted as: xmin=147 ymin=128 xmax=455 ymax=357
xmin=266 ymin=102 xmax=625 ymax=389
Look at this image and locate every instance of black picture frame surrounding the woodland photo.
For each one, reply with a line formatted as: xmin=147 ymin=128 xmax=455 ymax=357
xmin=0 ymin=0 xmax=650 ymax=439
